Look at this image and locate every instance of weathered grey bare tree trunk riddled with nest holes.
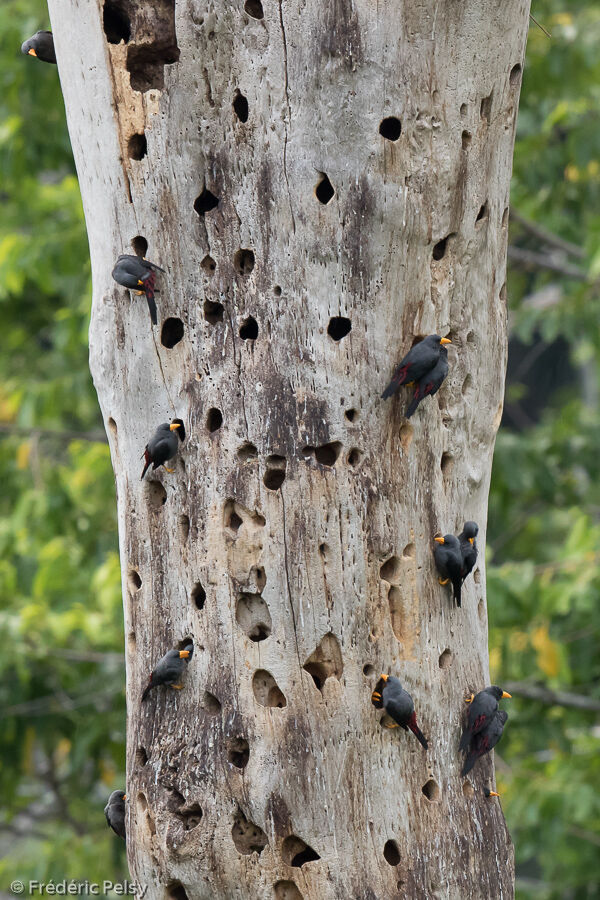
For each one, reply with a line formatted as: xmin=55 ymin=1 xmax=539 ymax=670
xmin=49 ymin=0 xmax=529 ymax=900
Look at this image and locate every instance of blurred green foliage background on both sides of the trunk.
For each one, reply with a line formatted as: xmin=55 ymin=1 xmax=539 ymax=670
xmin=0 ymin=0 xmax=600 ymax=900
